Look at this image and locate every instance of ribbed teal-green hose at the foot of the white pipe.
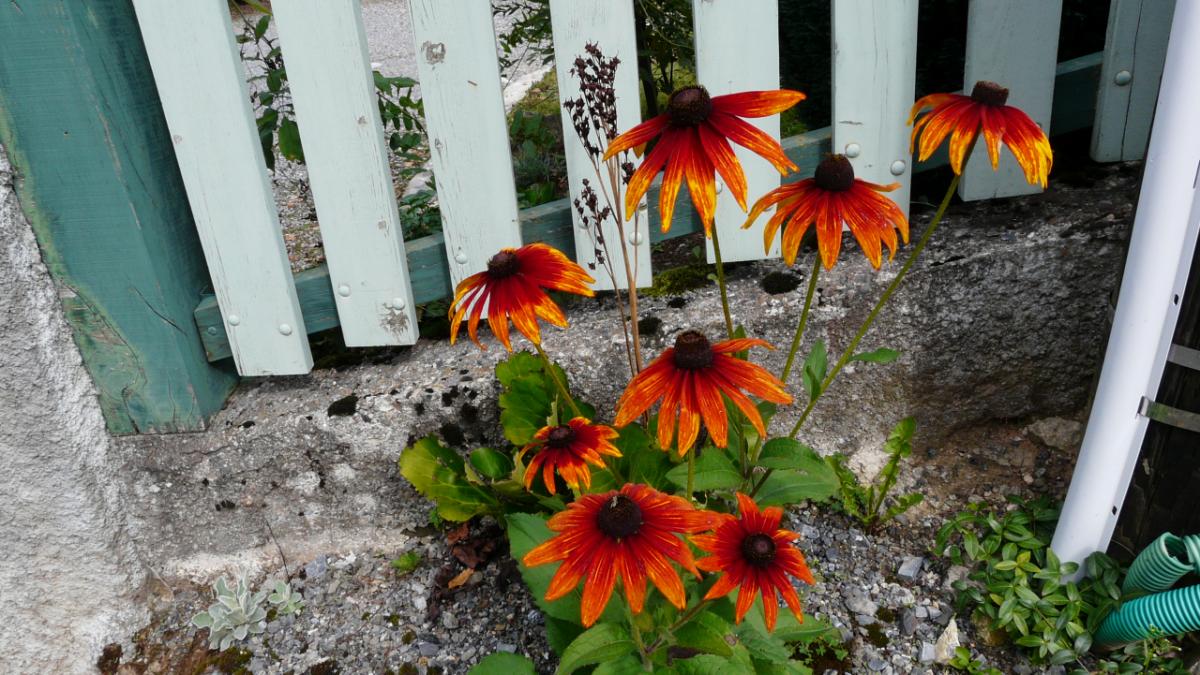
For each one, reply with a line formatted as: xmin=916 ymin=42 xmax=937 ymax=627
xmin=1094 ymin=532 xmax=1200 ymax=645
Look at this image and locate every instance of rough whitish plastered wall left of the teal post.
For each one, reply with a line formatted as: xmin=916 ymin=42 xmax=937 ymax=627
xmin=0 ymin=148 xmax=143 ymax=673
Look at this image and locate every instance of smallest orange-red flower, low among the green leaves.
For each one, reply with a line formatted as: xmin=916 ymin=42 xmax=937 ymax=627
xmin=521 ymin=417 xmax=620 ymax=495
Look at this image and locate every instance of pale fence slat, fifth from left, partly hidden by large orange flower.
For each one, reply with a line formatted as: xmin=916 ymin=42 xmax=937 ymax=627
xmin=692 ymin=0 xmax=777 ymax=262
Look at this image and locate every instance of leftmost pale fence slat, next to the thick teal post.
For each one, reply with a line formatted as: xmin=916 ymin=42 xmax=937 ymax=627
xmin=133 ymin=0 xmax=312 ymax=375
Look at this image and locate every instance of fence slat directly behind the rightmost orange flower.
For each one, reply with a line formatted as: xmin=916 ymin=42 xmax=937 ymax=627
xmin=959 ymin=0 xmax=1062 ymax=199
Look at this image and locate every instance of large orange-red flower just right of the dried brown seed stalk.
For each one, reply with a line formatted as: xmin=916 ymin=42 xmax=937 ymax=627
xmin=604 ymin=86 xmax=804 ymax=237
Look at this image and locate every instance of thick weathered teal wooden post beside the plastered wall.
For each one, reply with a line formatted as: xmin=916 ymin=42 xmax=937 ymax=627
xmin=0 ymin=0 xmax=236 ymax=434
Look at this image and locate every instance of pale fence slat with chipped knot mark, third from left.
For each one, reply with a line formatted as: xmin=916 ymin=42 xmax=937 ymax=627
xmin=408 ymin=0 xmax=521 ymax=285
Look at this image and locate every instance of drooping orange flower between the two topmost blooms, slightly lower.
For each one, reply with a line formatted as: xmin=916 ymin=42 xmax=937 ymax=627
xmin=742 ymin=155 xmax=908 ymax=269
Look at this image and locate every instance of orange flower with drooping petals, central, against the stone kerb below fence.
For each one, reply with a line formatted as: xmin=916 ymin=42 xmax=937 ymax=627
xmin=614 ymin=330 xmax=792 ymax=456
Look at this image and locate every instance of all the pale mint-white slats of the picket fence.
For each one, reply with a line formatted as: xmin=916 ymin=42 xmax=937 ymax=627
xmin=133 ymin=0 xmax=1172 ymax=375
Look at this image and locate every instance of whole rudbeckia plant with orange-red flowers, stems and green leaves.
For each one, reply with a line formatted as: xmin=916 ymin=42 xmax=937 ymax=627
xmin=400 ymin=46 xmax=1051 ymax=673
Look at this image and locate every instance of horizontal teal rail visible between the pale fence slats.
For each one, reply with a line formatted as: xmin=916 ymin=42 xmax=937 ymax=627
xmin=196 ymin=52 xmax=1102 ymax=360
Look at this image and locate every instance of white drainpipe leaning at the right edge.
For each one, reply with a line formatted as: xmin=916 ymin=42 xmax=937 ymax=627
xmin=1052 ymin=0 xmax=1200 ymax=562
